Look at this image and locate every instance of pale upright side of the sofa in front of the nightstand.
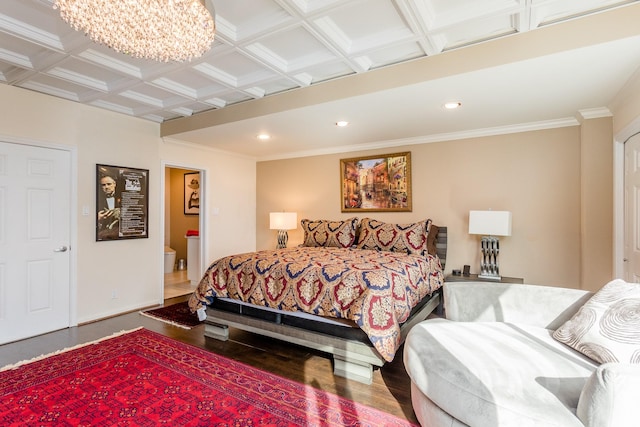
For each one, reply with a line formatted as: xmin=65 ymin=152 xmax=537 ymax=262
xmin=444 ymin=282 xmax=593 ymax=329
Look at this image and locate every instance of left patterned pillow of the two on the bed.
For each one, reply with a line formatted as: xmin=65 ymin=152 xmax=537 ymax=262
xmin=300 ymin=217 xmax=358 ymax=248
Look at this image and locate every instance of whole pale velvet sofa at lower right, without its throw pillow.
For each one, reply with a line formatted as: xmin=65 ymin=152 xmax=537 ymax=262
xmin=404 ymin=282 xmax=640 ymax=427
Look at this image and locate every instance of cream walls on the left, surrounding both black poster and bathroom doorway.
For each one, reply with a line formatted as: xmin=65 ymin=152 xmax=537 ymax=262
xmin=0 ymin=85 xmax=256 ymax=323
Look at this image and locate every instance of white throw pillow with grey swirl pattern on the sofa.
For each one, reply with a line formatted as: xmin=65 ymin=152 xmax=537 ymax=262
xmin=553 ymin=279 xmax=640 ymax=363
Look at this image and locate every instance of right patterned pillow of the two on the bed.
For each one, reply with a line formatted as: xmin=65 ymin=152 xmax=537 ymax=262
xmin=357 ymin=218 xmax=431 ymax=255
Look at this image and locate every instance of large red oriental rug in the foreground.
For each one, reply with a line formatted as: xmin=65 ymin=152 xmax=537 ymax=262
xmin=0 ymin=329 xmax=413 ymax=427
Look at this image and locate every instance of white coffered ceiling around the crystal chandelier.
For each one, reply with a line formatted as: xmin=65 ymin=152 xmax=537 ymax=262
xmin=0 ymin=0 xmax=638 ymax=157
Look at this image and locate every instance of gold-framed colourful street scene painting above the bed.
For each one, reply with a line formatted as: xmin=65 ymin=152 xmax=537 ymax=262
xmin=340 ymin=152 xmax=411 ymax=212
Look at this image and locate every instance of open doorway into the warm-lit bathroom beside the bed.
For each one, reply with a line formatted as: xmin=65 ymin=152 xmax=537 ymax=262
xmin=163 ymin=165 xmax=204 ymax=300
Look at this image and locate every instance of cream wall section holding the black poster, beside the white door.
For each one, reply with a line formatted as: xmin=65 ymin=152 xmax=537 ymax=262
xmin=0 ymin=85 xmax=162 ymax=321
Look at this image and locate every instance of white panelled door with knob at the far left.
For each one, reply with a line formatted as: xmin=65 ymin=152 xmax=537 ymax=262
xmin=0 ymin=142 xmax=71 ymax=344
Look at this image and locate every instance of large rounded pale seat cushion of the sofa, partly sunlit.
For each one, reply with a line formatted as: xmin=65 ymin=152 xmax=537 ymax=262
xmin=404 ymin=319 xmax=596 ymax=427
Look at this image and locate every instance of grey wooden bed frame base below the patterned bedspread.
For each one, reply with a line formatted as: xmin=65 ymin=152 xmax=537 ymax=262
xmin=204 ymin=293 xmax=440 ymax=384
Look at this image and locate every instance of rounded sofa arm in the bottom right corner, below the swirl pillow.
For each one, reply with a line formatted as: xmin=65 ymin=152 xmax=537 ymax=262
xmin=576 ymin=363 xmax=640 ymax=427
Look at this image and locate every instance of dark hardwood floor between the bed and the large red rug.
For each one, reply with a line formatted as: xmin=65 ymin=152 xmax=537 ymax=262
xmin=0 ymin=297 xmax=417 ymax=423
